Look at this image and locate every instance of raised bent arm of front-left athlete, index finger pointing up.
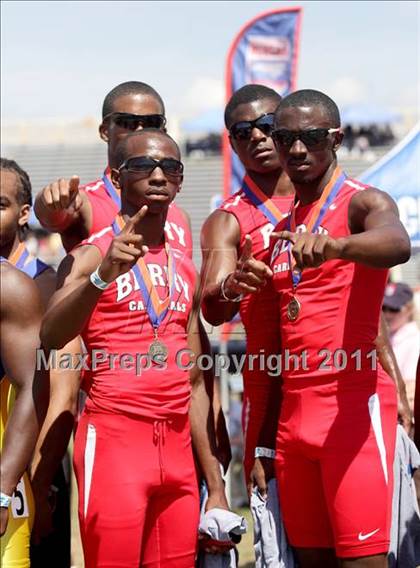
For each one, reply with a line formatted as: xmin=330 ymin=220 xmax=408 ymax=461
xmin=41 ymin=206 xmax=147 ymax=349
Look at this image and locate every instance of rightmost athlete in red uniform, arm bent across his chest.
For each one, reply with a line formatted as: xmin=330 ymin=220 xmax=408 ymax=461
xmin=271 ymin=90 xmax=410 ymax=568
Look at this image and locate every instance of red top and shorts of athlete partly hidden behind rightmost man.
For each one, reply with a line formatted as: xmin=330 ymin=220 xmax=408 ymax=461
xmin=221 ymin=176 xmax=293 ymax=479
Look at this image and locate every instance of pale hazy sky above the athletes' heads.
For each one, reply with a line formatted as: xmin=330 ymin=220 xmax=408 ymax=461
xmin=1 ymin=1 xmax=420 ymax=119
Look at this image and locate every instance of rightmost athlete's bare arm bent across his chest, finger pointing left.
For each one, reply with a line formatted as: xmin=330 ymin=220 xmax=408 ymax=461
xmin=272 ymin=188 xmax=410 ymax=269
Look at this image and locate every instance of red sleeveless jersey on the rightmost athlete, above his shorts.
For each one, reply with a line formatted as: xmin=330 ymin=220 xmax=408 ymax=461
xmin=270 ymin=179 xmax=388 ymax=378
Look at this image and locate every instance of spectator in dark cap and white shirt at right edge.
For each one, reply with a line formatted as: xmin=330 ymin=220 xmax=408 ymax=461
xmin=382 ymin=282 xmax=420 ymax=410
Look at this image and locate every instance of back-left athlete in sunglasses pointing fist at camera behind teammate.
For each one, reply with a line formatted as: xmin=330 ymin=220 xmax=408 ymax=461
xmin=35 ymin=81 xmax=192 ymax=256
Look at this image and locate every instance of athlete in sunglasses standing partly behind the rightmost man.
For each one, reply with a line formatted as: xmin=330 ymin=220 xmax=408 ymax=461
xmin=201 ymin=85 xmax=294 ymax=494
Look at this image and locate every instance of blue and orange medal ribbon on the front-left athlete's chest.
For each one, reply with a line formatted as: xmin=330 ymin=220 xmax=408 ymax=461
xmin=112 ymin=215 xmax=176 ymax=332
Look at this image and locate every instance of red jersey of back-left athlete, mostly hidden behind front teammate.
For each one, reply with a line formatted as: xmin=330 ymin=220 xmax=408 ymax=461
xmin=81 ymin=168 xmax=193 ymax=258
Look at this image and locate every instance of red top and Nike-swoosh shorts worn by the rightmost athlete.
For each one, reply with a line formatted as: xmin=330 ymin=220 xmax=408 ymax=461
xmin=271 ymin=179 xmax=397 ymax=557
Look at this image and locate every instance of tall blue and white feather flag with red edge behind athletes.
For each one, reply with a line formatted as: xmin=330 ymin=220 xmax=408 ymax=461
xmin=223 ymin=8 xmax=302 ymax=198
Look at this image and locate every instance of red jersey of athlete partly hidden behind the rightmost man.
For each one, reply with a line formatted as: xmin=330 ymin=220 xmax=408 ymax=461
xmin=220 ymin=182 xmax=294 ymax=352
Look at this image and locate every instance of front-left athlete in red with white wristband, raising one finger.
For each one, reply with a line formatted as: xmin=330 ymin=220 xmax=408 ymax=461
xmin=41 ymin=130 xmax=231 ymax=568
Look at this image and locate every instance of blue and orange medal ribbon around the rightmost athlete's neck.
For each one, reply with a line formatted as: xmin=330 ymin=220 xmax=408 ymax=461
xmin=287 ymin=166 xmax=347 ymax=289
